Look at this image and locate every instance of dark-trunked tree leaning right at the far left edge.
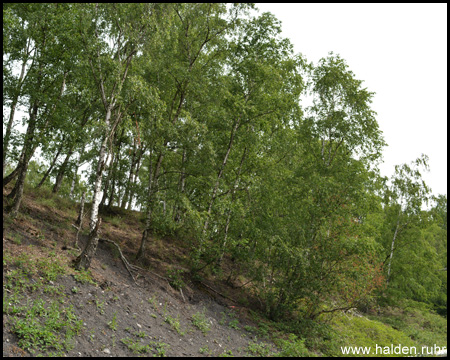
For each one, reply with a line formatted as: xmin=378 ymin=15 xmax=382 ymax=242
xmin=3 ymin=4 xmax=76 ymax=216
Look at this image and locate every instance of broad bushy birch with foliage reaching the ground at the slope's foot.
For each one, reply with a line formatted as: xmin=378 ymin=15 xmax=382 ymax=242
xmin=232 ymin=52 xmax=384 ymax=319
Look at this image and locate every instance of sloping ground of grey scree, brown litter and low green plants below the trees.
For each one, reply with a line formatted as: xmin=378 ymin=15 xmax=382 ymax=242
xmin=3 ymin=186 xmax=446 ymax=356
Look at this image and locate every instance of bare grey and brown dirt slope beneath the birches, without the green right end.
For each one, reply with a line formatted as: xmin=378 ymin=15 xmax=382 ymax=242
xmin=3 ymin=188 xmax=276 ymax=357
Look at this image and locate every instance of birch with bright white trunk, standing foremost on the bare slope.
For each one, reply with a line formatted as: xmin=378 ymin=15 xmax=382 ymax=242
xmin=74 ymin=4 xmax=155 ymax=269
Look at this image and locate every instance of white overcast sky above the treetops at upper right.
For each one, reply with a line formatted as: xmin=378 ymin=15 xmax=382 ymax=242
xmin=256 ymin=3 xmax=447 ymax=195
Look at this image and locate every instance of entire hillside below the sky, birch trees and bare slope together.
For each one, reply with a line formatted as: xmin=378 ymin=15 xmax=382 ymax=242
xmin=3 ymin=3 xmax=447 ymax=356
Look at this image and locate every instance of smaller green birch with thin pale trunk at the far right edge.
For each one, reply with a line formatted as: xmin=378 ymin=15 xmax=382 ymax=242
xmin=374 ymin=155 xmax=447 ymax=313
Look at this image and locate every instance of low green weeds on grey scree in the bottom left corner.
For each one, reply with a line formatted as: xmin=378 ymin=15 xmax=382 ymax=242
xmin=3 ymin=254 xmax=82 ymax=356
